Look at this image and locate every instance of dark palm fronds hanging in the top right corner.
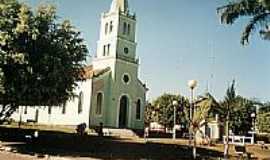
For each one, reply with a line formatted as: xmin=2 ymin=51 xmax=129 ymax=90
xmin=217 ymin=0 xmax=270 ymax=45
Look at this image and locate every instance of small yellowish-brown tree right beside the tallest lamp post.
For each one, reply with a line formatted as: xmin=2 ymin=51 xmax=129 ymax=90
xmin=191 ymin=93 xmax=219 ymax=159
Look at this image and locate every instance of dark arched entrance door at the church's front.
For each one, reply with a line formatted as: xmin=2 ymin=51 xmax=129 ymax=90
xmin=119 ymin=96 xmax=128 ymax=128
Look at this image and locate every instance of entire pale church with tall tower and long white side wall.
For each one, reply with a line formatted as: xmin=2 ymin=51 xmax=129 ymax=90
xmin=12 ymin=0 xmax=147 ymax=129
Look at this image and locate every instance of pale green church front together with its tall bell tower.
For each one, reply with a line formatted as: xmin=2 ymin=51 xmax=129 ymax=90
xmin=91 ymin=0 xmax=147 ymax=129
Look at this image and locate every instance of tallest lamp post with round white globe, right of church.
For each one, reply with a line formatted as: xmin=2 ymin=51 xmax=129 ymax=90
xmin=188 ymin=80 xmax=198 ymax=146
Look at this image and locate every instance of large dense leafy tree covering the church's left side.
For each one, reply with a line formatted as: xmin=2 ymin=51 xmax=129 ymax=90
xmin=0 ymin=0 xmax=88 ymax=120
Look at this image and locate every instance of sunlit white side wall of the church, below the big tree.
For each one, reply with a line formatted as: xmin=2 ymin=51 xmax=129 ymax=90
xmin=12 ymin=80 xmax=92 ymax=126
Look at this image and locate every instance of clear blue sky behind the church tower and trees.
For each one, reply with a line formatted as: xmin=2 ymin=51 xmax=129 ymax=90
xmin=24 ymin=0 xmax=270 ymax=101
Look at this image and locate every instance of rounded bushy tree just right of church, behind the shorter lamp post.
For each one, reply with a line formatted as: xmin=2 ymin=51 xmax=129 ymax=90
xmin=145 ymin=93 xmax=189 ymax=127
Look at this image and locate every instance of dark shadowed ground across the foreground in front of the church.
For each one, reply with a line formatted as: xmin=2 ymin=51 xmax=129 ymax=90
xmin=0 ymin=127 xmax=270 ymax=160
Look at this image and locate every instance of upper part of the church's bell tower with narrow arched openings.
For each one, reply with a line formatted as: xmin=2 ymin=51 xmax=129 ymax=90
xmin=93 ymin=0 xmax=137 ymax=69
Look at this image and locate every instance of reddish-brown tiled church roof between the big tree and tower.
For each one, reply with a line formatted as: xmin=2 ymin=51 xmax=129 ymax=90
xmin=81 ymin=65 xmax=111 ymax=79
